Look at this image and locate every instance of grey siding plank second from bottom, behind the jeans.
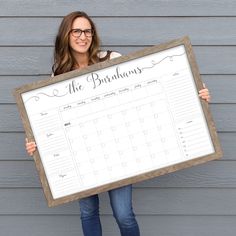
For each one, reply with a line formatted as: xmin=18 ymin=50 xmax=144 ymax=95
xmin=0 ymin=188 xmax=236 ymax=217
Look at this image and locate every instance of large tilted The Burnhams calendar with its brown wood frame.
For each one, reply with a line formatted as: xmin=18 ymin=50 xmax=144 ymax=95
xmin=14 ymin=37 xmax=222 ymax=206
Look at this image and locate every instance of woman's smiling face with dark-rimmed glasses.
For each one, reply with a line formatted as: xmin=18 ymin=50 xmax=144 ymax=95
xmin=69 ymin=17 xmax=93 ymax=54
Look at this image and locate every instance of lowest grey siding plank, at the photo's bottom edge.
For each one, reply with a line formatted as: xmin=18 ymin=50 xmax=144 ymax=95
xmin=0 ymin=215 xmax=236 ymax=236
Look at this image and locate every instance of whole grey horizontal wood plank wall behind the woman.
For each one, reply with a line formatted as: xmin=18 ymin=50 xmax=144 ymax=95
xmin=0 ymin=0 xmax=236 ymax=236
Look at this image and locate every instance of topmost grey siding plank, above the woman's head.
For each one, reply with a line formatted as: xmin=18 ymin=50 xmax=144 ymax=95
xmin=0 ymin=0 xmax=236 ymax=17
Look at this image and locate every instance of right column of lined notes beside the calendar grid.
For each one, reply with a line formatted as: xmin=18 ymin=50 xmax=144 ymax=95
xmin=164 ymin=68 xmax=214 ymax=160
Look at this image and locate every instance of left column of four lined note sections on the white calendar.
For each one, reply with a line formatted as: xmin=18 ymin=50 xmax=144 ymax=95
xmin=30 ymin=109 xmax=80 ymax=198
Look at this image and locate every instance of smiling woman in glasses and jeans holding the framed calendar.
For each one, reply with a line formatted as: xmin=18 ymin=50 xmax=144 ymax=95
xmin=26 ymin=12 xmax=210 ymax=236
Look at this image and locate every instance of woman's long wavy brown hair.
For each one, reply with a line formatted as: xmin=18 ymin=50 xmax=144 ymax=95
xmin=52 ymin=11 xmax=100 ymax=75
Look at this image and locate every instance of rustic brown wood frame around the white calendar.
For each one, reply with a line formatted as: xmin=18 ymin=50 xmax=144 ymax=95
xmin=14 ymin=36 xmax=222 ymax=207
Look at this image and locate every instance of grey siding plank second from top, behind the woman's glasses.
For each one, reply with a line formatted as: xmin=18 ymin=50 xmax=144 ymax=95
xmin=0 ymin=17 xmax=236 ymax=47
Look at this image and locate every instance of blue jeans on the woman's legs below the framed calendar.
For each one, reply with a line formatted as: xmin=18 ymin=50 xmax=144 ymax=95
xmin=79 ymin=185 xmax=140 ymax=236
